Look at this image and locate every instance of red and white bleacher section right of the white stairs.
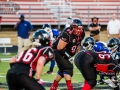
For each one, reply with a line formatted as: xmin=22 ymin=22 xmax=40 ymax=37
xmin=67 ymin=0 xmax=120 ymax=25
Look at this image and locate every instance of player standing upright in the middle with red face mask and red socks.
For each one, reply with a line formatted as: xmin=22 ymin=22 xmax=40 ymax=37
xmin=50 ymin=19 xmax=85 ymax=90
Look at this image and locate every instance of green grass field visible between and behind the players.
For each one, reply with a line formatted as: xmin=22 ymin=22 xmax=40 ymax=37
xmin=0 ymin=53 xmax=83 ymax=90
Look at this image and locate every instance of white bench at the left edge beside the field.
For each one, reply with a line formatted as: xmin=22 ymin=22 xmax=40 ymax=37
xmin=0 ymin=38 xmax=13 ymax=54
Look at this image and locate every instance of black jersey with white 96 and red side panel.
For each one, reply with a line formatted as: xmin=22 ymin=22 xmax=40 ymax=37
xmin=13 ymin=46 xmax=55 ymax=76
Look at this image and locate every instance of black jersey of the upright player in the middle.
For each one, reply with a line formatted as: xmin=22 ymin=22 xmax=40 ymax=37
xmin=53 ymin=28 xmax=85 ymax=56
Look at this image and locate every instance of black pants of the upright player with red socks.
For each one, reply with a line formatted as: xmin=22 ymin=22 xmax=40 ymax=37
xmin=55 ymin=50 xmax=73 ymax=77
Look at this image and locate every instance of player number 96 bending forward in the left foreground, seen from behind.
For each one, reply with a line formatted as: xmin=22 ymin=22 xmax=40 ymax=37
xmin=6 ymin=29 xmax=54 ymax=90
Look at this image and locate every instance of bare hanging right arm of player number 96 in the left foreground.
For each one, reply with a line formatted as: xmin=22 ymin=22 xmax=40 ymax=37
xmin=36 ymin=56 xmax=46 ymax=80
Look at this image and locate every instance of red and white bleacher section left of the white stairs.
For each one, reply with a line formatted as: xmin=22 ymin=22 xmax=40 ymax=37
xmin=1 ymin=0 xmax=58 ymax=25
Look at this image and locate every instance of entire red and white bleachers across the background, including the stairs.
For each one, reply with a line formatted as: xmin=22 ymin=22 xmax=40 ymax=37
xmin=0 ymin=0 xmax=120 ymax=25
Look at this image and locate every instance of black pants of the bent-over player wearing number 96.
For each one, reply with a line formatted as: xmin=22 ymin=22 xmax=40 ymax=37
xmin=6 ymin=69 xmax=45 ymax=90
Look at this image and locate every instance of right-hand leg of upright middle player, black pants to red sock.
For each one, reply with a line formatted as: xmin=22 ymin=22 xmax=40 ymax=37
xmin=55 ymin=51 xmax=73 ymax=90
